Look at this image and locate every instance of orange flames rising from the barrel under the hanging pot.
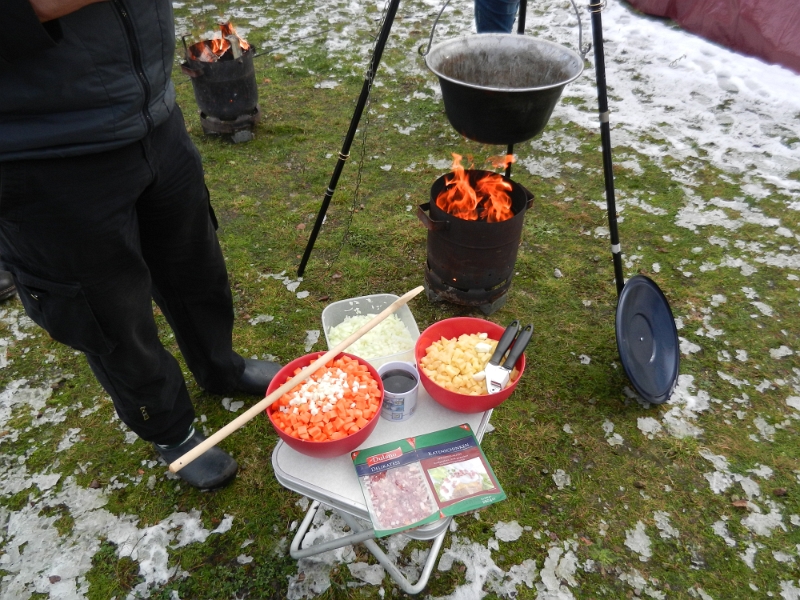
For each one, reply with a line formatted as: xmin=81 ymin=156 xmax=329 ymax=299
xmin=436 ymin=153 xmax=514 ymax=223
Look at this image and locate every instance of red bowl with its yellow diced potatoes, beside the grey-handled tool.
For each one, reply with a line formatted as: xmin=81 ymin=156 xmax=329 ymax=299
xmin=414 ymin=317 xmax=525 ymax=413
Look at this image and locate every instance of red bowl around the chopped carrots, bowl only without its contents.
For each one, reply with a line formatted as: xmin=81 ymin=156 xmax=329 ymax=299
xmin=266 ymin=352 xmax=383 ymax=458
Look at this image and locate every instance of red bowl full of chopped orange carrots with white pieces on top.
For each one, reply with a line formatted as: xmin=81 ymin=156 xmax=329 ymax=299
xmin=267 ymin=352 xmax=383 ymax=458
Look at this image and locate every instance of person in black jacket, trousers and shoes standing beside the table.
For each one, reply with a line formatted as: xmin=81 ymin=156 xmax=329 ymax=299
xmin=0 ymin=0 xmax=280 ymax=489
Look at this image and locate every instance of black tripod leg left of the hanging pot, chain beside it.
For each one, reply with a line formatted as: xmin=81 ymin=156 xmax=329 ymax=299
xmin=297 ymin=0 xmax=400 ymax=276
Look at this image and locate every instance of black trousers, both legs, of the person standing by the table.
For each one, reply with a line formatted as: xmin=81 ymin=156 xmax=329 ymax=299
xmin=0 ymin=107 xmax=244 ymax=444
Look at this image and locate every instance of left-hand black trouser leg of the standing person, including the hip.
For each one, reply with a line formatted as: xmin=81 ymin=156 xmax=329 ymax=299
xmin=0 ymin=129 xmax=194 ymax=443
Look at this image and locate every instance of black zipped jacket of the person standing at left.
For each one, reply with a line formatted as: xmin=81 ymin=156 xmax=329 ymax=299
xmin=0 ymin=0 xmax=175 ymax=161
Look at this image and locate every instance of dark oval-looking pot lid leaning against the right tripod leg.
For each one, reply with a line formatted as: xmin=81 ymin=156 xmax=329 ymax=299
xmin=616 ymin=275 xmax=680 ymax=404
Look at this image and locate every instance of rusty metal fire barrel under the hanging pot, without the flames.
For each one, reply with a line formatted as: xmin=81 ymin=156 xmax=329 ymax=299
xmin=417 ymin=169 xmax=533 ymax=315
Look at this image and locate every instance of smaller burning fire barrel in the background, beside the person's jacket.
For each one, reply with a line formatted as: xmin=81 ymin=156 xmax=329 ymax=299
xmin=181 ymin=23 xmax=261 ymax=141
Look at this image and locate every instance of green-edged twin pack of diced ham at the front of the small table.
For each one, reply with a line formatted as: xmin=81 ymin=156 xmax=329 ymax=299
xmin=350 ymin=423 xmax=506 ymax=537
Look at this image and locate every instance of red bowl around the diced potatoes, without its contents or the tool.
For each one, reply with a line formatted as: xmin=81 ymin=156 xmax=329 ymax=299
xmin=414 ymin=317 xmax=525 ymax=413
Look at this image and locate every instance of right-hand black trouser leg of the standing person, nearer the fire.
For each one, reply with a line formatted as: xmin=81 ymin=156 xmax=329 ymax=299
xmin=136 ymin=107 xmax=244 ymax=393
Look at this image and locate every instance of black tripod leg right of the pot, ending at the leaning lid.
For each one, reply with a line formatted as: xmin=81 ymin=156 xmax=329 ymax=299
xmin=589 ymin=0 xmax=625 ymax=296
